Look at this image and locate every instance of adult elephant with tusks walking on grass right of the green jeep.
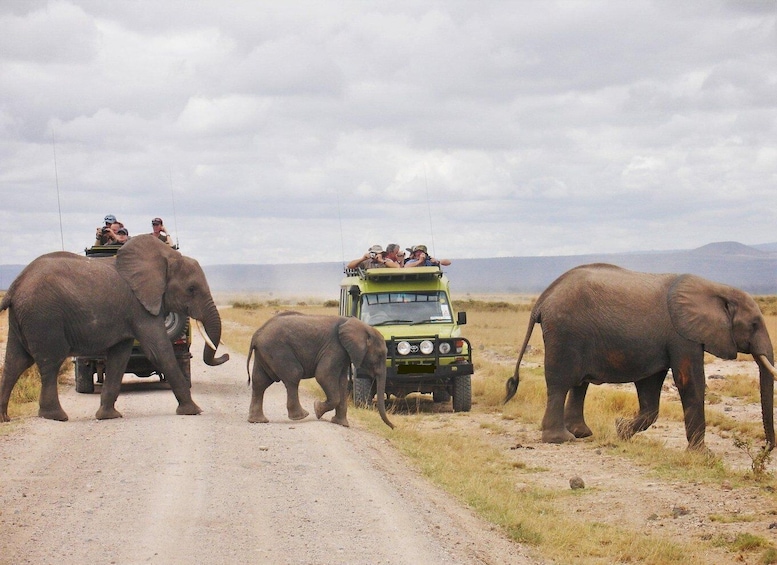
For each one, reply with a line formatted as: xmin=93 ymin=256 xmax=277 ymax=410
xmin=504 ymin=264 xmax=776 ymax=450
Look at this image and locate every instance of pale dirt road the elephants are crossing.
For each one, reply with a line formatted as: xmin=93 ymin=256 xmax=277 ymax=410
xmin=0 ymin=343 xmax=530 ymax=565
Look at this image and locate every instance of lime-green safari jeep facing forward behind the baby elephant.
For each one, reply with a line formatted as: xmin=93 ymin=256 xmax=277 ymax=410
xmin=340 ymin=267 xmax=473 ymax=412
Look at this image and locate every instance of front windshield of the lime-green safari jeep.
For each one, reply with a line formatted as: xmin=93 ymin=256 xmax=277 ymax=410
xmin=361 ymin=291 xmax=453 ymax=326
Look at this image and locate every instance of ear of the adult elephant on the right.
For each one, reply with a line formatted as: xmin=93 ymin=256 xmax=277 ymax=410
xmin=668 ymin=275 xmax=737 ymax=359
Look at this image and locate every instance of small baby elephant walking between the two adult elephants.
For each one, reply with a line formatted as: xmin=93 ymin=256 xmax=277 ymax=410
xmin=246 ymin=312 xmax=394 ymax=428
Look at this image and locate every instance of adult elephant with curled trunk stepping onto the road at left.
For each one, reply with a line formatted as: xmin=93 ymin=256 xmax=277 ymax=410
xmin=0 ymin=234 xmax=229 ymax=422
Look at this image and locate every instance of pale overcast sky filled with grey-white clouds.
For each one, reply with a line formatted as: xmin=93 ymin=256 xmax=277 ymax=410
xmin=0 ymin=0 xmax=777 ymax=265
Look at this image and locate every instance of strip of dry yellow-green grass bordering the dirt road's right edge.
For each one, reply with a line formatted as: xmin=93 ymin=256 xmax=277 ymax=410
xmin=354 ymin=410 xmax=704 ymax=564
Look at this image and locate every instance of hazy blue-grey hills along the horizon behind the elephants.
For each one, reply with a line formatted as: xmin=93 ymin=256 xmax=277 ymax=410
xmin=0 ymin=242 xmax=777 ymax=299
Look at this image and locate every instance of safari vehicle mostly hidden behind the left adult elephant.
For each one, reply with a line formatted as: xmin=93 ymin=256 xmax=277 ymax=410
xmin=74 ymin=245 xmax=192 ymax=394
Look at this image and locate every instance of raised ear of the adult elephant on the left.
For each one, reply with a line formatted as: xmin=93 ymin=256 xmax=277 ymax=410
xmin=116 ymin=234 xmax=177 ymax=316
